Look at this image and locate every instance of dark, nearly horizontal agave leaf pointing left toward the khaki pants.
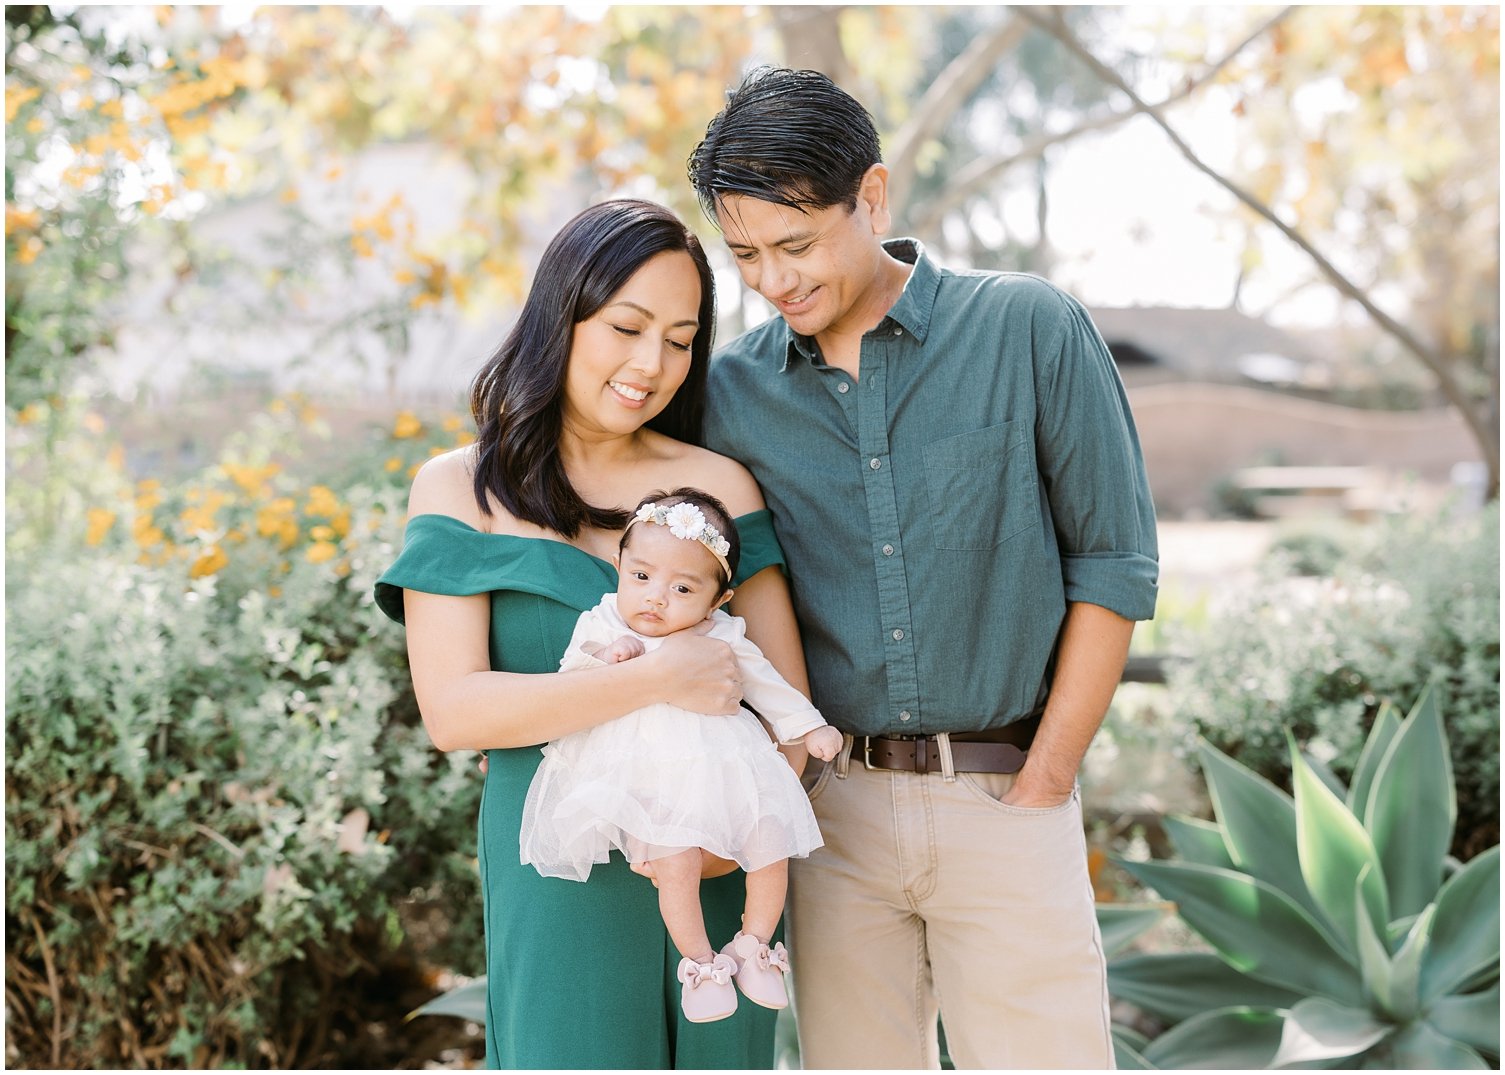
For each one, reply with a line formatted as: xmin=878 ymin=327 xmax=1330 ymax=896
xmin=1108 ymin=952 xmax=1305 ymax=1022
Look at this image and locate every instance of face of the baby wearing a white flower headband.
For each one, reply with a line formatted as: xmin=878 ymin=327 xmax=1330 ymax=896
xmin=617 ymin=522 xmax=722 ymax=638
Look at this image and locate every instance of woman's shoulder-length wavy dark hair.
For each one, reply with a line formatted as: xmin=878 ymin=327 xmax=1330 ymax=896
xmin=471 ymin=199 xmax=716 ymax=538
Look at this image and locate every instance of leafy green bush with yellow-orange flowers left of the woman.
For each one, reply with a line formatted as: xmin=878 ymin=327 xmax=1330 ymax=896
xmin=6 ymin=394 xmax=480 ymax=1067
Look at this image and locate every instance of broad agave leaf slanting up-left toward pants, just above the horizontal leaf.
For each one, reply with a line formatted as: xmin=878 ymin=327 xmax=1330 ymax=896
xmin=1118 ymin=860 xmax=1364 ymax=1005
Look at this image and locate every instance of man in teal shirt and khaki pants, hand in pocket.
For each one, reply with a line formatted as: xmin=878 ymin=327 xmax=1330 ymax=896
xmin=689 ymin=69 xmax=1157 ymax=1067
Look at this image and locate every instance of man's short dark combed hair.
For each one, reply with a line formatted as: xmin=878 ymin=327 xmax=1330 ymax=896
xmin=689 ymin=68 xmax=883 ymax=220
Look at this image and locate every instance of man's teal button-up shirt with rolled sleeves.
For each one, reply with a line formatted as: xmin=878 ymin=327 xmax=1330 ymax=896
xmin=706 ymin=239 xmax=1159 ymax=735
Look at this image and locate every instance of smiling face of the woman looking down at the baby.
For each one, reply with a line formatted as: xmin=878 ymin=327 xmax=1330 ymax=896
xmin=564 ymin=250 xmax=700 ymax=440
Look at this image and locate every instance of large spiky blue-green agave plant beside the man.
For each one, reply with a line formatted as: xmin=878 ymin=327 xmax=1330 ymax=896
xmin=1105 ymin=688 xmax=1500 ymax=1069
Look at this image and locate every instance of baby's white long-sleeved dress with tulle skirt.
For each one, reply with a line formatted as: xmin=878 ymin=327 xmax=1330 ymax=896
xmin=519 ymin=593 xmax=825 ymax=881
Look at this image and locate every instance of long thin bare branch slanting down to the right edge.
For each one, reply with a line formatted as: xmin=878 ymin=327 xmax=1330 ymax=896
xmin=1014 ymin=6 xmax=1499 ymax=480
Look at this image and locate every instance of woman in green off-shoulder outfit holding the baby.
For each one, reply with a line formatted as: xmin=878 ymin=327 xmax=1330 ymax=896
xmin=376 ymin=200 xmax=808 ymax=1067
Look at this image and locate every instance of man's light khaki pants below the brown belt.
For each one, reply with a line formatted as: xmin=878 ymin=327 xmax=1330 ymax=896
xmin=789 ymin=739 xmax=1114 ymax=1069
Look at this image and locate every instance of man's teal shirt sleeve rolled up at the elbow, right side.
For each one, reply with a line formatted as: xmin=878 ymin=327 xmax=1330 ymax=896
xmin=1035 ymin=294 xmax=1160 ymax=620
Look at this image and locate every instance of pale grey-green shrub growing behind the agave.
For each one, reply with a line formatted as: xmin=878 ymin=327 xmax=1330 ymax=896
xmin=1168 ymin=504 xmax=1500 ymax=858
